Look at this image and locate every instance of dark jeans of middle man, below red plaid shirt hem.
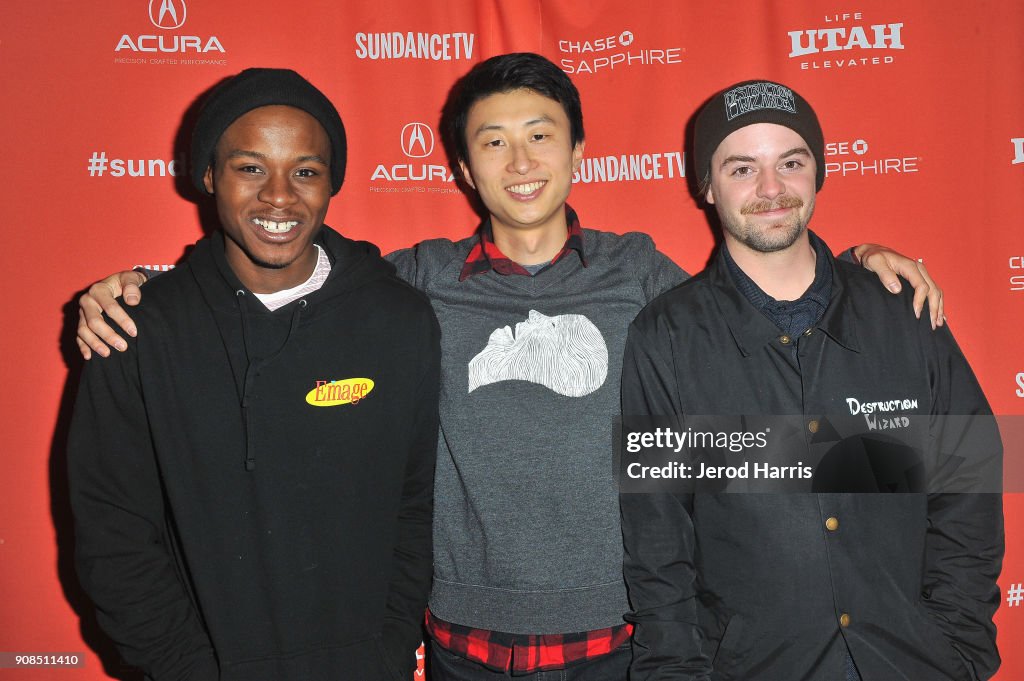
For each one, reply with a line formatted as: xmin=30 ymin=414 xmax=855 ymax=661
xmin=427 ymin=642 xmax=633 ymax=681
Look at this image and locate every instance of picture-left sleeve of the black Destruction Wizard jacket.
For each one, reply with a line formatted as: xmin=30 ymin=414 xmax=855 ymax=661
xmin=618 ymin=326 xmax=712 ymax=681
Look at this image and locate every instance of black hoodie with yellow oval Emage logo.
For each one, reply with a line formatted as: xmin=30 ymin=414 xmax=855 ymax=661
xmin=69 ymin=227 xmax=439 ymax=681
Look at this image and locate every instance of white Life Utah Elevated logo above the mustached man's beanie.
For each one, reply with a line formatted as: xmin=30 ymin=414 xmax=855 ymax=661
xmin=788 ymin=12 xmax=903 ymax=71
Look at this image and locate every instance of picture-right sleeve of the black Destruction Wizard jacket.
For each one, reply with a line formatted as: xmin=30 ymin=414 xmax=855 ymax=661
xmin=922 ymin=321 xmax=1004 ymax=681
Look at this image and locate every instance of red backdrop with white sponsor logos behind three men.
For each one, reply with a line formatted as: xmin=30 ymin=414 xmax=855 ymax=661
xmin=0 ymin=0 xmax=1024 ymax=681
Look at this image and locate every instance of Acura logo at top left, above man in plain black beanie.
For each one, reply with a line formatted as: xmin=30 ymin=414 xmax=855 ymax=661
xmin=114 ymin=0 xmax=227 ymax=66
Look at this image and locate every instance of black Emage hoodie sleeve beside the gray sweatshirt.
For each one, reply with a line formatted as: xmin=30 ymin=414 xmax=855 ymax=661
xmin=383 ymin=311 xmax=440 ymax=678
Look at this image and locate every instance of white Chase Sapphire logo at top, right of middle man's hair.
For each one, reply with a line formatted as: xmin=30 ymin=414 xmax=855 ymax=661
xmin=558 ymin=29 xmax=685 ymax=75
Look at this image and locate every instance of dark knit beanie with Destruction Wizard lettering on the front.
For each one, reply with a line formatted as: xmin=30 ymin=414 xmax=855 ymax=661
xmin=693 ymin=81 xmax=825 ymax=190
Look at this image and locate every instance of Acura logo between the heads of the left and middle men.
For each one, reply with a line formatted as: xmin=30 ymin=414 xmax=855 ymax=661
xmin=370 ymin=121 xmax=460 ymax=194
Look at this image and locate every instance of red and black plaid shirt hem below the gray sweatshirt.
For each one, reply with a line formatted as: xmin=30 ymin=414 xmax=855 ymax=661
xmin=426 ymin=610 xmax=633 ymax=675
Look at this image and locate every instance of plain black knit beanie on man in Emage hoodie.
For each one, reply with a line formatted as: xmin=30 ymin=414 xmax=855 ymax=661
xmin=191 ymin=69 xmax=346 ymax=196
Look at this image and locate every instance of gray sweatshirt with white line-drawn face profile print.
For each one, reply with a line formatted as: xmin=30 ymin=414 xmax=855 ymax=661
xmin=388 ymin=229 xmax=686 ymax=634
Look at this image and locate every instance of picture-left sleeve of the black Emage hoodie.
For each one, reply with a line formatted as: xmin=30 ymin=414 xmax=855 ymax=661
xmin=68 ymin=341 xmax=219 ymax=681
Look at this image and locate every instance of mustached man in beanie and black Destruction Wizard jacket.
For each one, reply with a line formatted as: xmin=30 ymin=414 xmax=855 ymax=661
xmin=621 ymin=81 xmax=1004 ymax=681
